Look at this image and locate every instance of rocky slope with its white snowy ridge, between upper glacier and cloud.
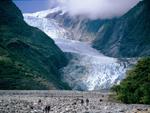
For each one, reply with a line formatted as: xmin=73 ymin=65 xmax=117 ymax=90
xmin=28 ymin=5 xmax=107 ymax=42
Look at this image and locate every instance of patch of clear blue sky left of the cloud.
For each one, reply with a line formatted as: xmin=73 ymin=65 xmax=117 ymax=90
xmin=13 ymin=0 xmax=55 ymax=13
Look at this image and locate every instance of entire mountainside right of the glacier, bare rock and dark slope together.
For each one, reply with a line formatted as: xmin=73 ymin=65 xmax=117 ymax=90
xmin=37 ymin=0 xmax=150 ymax=57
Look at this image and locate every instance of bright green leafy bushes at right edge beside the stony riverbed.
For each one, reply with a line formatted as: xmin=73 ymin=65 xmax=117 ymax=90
xmin=112 ymin=57 xmax=150 ymax=104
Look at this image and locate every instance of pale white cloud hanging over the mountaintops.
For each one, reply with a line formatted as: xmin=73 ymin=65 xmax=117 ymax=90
xmin=60 ymin=0 xmax=141 ymax=19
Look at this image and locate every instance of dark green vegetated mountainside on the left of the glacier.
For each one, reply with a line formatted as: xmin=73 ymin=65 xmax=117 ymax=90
xmin=0 ymin=0 xmax=69 ymax=89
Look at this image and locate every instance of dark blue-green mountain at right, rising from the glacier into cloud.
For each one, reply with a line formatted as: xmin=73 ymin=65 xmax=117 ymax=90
xmin=93 ymin=0 xmax=150 ymax=57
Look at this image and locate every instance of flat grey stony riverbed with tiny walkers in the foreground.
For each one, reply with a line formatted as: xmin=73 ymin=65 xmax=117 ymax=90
xmin=0 ymin=91 xmax=150 ymax=113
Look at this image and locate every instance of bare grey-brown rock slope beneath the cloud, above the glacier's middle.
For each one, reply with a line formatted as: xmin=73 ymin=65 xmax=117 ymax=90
xmin=46 ymin=11 xmax=106 ymax=42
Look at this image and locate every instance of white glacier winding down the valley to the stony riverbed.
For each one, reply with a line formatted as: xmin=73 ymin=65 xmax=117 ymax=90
xmin=24 ymin=8 xmax=136 ymax=90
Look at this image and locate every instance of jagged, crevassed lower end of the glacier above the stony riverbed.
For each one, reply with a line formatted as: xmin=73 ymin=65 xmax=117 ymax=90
xmin=62 ymin=55 xmax=129 ymax=90
